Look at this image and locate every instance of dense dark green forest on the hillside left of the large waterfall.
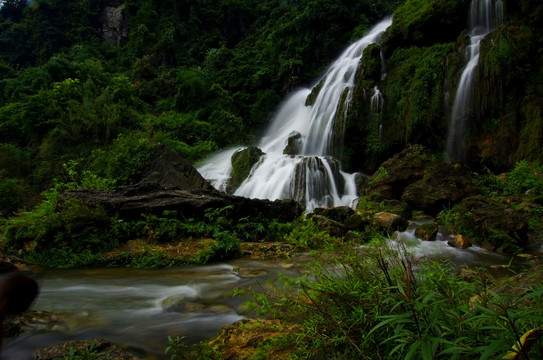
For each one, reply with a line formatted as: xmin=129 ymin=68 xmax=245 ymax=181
xmin=0 ymin=0 xmax=398 ymax=215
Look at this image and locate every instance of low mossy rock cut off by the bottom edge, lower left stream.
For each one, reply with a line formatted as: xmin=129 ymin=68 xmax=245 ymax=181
xmin=36 ymin=339 xmax=138 ymax=360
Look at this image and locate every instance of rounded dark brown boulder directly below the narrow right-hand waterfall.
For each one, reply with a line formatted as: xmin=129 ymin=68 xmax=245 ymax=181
xmin=402 ymin=162 xmax=479 ymax=215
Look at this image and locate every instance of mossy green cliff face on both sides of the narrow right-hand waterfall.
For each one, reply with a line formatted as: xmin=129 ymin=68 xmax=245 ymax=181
xmin=342 ymin=0 xmax=543 ymax=172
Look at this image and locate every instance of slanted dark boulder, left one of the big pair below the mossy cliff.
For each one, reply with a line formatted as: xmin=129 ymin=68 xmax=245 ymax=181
xmin=364 ymin=145 xmax=433 ymax=201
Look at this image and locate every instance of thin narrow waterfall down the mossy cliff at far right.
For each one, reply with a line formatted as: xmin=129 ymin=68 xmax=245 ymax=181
xmin=447 ymin=0 xmax=503 ymax=161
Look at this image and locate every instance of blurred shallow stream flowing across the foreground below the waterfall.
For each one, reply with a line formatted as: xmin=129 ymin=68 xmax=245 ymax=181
xmin=3 ymin=235 xmax=520 ymax=360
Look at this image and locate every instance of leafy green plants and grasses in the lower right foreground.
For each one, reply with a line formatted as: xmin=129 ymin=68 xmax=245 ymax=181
xmin=244 ymin=243 xmax=543 ymax=359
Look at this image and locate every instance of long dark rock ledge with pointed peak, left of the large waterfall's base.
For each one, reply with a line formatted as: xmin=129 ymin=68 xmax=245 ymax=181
xmin=60 ymin=146 xmax=304 ymax=221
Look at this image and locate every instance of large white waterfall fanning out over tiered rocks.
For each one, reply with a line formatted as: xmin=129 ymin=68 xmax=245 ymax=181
xmin=198 ymin=18 xmax=392 ymax=211
